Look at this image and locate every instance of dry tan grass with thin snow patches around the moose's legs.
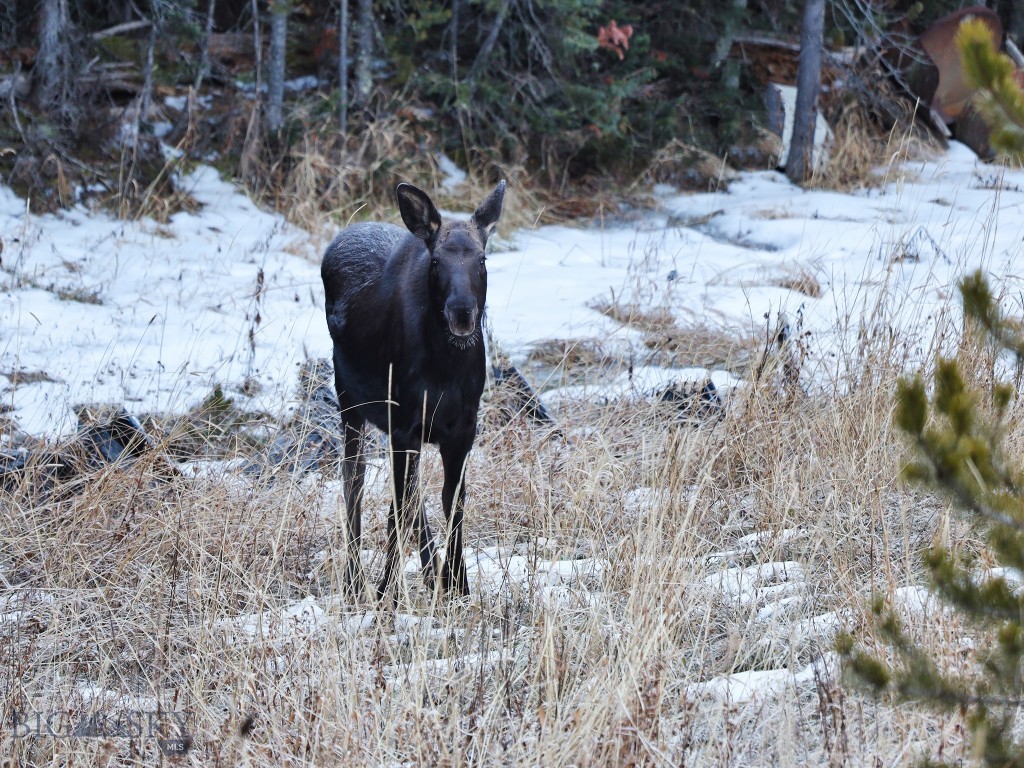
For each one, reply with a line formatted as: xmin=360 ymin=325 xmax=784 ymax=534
xmin=0 ymin=260 xmax=1007 ymax=766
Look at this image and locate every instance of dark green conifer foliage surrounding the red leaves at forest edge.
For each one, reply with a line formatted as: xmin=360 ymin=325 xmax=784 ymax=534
xmin=380 ymin=0 xmax=790 ymax=179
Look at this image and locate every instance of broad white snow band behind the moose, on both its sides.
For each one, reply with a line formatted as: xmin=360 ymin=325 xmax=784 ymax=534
xmin=0 ymin=143 xmax=1024 ymax=434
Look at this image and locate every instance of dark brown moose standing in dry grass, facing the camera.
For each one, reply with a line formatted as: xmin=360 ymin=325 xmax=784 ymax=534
xmin=321 ymin=181 xmax=505 ymax=600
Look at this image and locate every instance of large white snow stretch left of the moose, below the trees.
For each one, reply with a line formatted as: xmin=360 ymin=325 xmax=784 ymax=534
xmin=0 ymin=162 xmax=330 ymax=435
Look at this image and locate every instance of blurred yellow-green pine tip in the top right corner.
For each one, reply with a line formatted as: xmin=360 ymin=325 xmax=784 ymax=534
xmin=956 ymin=19 xmax=1024 ymax=161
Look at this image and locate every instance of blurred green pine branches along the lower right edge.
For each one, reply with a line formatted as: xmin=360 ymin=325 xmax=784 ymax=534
xmin=837 ymin=272 xmax=1024 ymax=767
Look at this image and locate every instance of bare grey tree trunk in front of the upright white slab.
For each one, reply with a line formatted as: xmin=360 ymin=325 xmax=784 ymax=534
xmin=785 ymin=0 xmax=825 ymax=183
